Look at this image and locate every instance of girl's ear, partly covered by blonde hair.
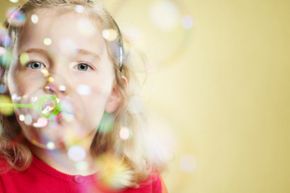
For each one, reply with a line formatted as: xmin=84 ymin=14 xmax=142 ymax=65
xmin=105 ymin=76 xmax=128 ymax=113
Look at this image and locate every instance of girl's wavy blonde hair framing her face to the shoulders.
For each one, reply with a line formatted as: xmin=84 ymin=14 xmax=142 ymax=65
xmin=0 ymin=0 xmax=161 ymax=185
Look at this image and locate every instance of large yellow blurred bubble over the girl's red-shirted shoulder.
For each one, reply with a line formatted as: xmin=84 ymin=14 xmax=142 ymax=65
xmin=96 ymin=154 xmax=133 ymax=189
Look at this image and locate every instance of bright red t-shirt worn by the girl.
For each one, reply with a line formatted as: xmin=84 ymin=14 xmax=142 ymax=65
xmin=0 ymin=157 xmax=162 ymax=193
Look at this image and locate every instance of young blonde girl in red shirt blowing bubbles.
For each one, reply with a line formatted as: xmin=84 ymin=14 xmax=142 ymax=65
xmin=0 ymin=0 xmax=166 ymax=193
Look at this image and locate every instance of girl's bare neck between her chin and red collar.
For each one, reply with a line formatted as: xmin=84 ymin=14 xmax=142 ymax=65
xmin=28 ymin=139 xmax=96 ymax=176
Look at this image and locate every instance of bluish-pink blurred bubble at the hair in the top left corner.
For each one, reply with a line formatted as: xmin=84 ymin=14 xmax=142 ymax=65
xmin=6 ymin=8 xmax=26 ymax=27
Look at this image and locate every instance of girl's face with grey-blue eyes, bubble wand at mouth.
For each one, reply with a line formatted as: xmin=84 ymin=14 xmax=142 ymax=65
xmin=8 ymin=7 xmax=120 ymax=148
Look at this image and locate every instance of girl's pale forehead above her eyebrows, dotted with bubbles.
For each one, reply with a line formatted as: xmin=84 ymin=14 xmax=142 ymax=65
xmin=19 ymin=8 xmax=105 ymax=56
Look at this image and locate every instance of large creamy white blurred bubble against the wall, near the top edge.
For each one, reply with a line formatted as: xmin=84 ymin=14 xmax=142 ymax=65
xmin=150 ymin=0 xmax=180 ymax=31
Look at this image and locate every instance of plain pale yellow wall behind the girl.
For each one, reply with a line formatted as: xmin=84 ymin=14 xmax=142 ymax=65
xmin=0 ymin=0 xmax=290 ymax=193
